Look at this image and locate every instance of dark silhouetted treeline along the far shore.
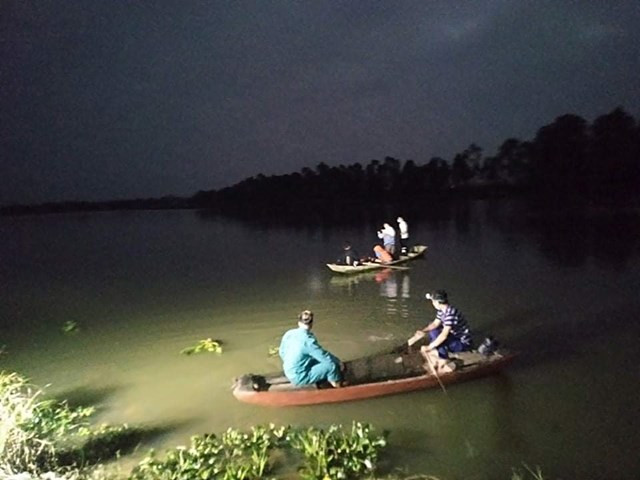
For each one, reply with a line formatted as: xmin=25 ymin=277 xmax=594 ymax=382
xmin=0 ymin=107 xmax=640 ymax=214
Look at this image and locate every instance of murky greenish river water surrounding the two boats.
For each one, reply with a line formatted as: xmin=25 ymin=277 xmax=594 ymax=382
xmin=0 ymin=202 xmax=640 ymax=480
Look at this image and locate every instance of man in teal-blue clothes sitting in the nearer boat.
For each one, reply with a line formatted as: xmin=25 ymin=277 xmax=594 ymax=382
xmin=280 ymin=310 xmax=342 ymax=388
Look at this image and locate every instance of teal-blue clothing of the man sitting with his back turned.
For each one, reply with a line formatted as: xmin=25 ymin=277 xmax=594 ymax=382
xmin=279 ymin=327 xmax=340 ymax=385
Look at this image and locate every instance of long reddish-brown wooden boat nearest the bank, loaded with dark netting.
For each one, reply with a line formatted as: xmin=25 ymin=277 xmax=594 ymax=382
xmin=233 ymin=344 xmax=515 ymax=407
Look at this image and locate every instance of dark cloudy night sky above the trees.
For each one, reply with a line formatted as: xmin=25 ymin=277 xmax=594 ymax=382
xmin=0 ymin=0 xmax=640 ymax=204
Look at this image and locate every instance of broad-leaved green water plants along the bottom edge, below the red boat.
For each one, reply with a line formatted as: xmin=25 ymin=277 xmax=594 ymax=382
xmin=130 ymin=422 xmax=386 ymax=480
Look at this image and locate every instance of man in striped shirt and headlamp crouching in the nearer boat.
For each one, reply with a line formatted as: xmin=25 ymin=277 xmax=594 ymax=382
xmin=408 ymin=290 xmax=473 ymax=373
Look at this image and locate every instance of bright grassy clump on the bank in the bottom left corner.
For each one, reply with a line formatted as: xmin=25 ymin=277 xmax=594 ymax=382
xmin=0 ymin=372 xmax=141 ymax=479
